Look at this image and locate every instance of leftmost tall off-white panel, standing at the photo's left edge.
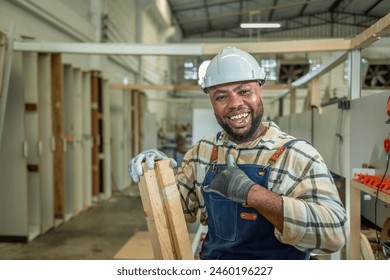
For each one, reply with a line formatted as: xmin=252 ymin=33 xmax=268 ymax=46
xmin=0 ymin=53 xmax=42 ymax=242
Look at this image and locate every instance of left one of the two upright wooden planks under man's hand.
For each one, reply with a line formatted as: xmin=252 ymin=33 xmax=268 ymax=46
xmin=139 ymin=163 xmax=175 ymax=260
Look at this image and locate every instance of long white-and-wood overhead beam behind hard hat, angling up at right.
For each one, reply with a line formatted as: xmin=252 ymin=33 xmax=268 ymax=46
xmin=13 ymin=13 xmax=390 ymax=56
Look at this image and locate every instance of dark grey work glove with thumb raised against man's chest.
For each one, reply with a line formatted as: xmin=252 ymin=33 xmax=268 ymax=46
xmin=204 ymin=155 xmax=256 ymax=204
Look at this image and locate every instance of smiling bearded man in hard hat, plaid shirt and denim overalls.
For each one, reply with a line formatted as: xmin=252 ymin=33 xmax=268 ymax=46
xmin=129 ymin=47 xmax=347 ymax=260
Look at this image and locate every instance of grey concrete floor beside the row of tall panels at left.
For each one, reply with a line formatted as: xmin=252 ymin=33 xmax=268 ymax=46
xmin=0 ymin=190 xmax=147 ymax=260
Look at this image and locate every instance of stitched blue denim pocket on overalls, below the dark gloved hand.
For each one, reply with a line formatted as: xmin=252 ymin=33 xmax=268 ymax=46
xmin=210 ymin=196 xmax=238 ymax=241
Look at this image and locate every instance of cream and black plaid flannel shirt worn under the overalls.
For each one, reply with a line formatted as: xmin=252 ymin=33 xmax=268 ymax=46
xmin=177 ymin=122 xmax=347 ymax=253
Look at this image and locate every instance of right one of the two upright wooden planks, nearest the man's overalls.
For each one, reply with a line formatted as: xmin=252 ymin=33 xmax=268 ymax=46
xmin=155 ymin=160 xmax=194 ymax=260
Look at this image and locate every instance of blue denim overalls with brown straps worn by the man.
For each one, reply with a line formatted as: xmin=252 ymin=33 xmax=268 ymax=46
xmin=200 ymin=139 xmax=309 ymax=260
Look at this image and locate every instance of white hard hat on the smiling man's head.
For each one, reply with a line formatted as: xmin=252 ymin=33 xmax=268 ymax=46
xmin=200 ymin=47 xmax=265 ymax=92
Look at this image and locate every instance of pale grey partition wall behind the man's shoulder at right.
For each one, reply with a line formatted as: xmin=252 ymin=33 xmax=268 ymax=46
xmin=278 ymin=91 xmax=390 ymax=230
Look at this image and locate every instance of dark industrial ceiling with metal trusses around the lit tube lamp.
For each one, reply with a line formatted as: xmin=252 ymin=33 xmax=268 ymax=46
xmin=168 ymin=0 xmax=390 ymax=40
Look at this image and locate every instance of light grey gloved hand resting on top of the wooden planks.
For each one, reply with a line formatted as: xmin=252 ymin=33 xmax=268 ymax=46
xmin=129 ymin=149 xmax=177 ymax=183
